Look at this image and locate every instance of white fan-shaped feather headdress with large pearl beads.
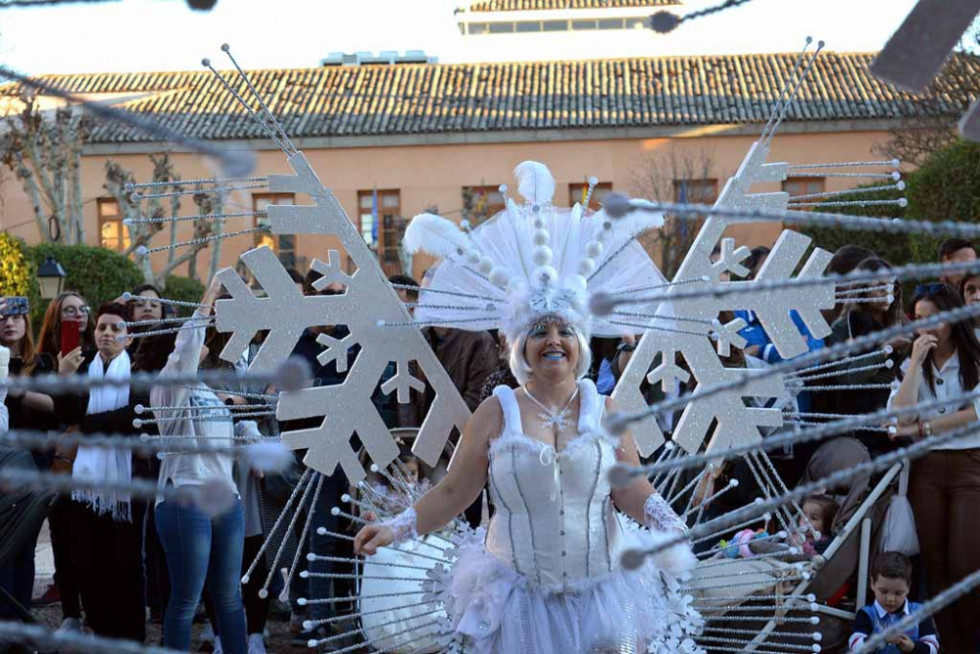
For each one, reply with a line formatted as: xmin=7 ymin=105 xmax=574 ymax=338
xmin=403 ymin=161 xmax=666 ymax=342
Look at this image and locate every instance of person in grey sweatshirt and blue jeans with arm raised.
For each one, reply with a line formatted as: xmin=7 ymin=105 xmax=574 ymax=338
xmin=150 ymin=281 xmax=259 ymax=654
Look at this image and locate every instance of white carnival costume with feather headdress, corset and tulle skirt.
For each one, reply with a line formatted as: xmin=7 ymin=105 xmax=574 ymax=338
xmin=369 ymin=162 xmax=701 ymax=654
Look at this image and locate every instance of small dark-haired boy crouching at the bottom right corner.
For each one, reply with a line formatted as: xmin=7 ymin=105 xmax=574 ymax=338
xmin=848 ymin=552 xmax=939 ymax=654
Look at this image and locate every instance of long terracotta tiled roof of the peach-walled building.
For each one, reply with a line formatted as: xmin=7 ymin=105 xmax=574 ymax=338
xmin=0 ymin=53 xmax=980 ymax=143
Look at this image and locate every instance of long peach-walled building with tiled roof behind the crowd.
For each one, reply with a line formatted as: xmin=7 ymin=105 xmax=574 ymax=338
xmin=0 ymin=52 xmax=980 ymax=275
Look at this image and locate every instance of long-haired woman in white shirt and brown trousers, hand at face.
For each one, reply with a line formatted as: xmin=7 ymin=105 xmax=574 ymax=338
xmin=888 ymin=283 xmax=980 ymax=653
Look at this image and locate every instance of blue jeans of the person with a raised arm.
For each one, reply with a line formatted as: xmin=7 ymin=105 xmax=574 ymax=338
xmin=155 ymin=500 xmax=245 ymax=653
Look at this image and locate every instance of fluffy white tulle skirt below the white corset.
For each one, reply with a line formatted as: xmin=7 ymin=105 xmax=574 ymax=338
xmin=446 ymin=537 xmax=701 ymax=654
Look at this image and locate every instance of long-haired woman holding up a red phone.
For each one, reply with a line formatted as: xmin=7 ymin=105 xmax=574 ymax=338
xmin=36 ymin=291 xmax=95 ymax=631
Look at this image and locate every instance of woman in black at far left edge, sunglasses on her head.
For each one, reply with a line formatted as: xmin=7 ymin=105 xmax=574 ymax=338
xmin=0 ymin=298 xmax=57 ymax=624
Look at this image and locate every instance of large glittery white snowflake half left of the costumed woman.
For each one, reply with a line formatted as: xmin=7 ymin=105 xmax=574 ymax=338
xmin=216 ymin=152 xmax=470 ymax=482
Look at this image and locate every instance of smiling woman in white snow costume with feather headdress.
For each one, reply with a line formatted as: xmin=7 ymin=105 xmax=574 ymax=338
xmin=355 ymin=162 xmax=700 ymax=654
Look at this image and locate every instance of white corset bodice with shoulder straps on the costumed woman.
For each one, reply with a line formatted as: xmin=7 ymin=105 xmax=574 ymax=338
xmin=486 ymin=380 xmax=622 ymax=590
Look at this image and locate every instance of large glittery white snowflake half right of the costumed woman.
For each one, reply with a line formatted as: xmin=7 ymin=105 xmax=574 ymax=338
xmin=613 ymin=140 xmax=834 ymax=456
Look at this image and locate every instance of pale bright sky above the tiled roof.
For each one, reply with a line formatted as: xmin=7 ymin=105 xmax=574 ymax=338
xmin=0 ymin=0 xmax=915 ymax=75
